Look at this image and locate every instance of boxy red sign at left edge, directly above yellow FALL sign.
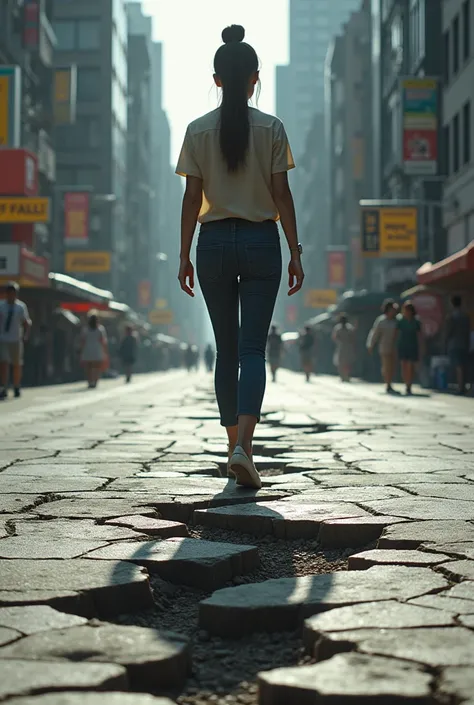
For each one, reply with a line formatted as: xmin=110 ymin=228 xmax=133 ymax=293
xmin=0 ymin=149 xmax=38 ymax=196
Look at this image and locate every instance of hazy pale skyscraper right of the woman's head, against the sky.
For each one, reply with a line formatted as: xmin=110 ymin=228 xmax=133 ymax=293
xmin=277 ymin=0 xmax=360 ymax=159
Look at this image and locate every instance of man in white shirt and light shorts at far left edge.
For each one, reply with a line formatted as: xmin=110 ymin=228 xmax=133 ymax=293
xmin=0 ymin=282 xmax=31 ymax=401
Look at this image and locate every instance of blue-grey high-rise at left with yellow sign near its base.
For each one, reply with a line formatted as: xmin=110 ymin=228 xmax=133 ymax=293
xmin=54 ymin=0 xmax=127 ymax=299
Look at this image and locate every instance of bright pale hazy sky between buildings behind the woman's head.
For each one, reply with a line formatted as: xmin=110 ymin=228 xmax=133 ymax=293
xmin=142 ymin=0 xmax=289 ymax=161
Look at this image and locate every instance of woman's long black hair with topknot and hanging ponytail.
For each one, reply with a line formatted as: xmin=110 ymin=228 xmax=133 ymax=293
xmin=214 ymin=24 xmax=258 ymax=172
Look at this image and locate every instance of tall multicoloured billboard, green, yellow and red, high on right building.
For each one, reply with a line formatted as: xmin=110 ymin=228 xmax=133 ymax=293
xmin=400 ymin=78 xmax=438 ymax=176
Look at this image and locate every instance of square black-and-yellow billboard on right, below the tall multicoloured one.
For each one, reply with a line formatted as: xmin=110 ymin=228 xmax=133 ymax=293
xmin=361 ymin=201 xmax=418 ymax=259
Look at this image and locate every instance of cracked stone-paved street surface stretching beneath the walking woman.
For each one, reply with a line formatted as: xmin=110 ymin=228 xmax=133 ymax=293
xmin=0 ymin=370 xmax=474 ymax=705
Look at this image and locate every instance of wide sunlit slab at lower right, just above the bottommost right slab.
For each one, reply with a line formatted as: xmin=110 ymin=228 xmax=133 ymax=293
xmin=304 ymin=595 xmax=456 ymax=654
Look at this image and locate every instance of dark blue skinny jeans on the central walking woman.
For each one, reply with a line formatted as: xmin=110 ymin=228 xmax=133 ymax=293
xmin=197 ymin=218 xmax=281 ymax=426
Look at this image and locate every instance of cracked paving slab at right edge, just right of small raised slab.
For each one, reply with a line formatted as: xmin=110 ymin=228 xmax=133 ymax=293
xmin=378 ymin=520 xmax=474 ymax=549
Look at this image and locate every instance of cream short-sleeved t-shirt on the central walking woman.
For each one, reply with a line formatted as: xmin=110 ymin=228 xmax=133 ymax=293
xmin=176 ymin=108 xmax=295 ymax=223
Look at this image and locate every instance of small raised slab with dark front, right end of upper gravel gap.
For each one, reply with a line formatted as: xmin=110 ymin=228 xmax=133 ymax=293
xmin=318 ymin=515 xmax=406 ymax=548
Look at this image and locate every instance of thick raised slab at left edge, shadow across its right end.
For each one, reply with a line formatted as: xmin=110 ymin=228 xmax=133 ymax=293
xmin=0 ymin=558 xmax=154 ymax=617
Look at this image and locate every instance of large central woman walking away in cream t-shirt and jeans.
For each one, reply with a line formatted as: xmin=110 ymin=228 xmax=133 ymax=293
xmin=176 ymin=25 xmax=304 ymax=488
